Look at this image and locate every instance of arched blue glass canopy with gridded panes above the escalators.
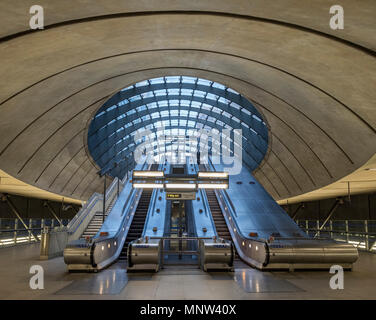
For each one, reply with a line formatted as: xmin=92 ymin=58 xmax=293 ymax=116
xmin=88 ymin=76 xmax=268 ymax=179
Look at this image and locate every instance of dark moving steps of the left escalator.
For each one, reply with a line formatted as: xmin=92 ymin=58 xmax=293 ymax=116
xmin=119 ymin=189 xmax=153 ymax=260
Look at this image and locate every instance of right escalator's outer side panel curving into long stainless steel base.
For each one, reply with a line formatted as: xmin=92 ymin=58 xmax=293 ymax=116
xmin=212 ymin=185 xmax=358 ymax=270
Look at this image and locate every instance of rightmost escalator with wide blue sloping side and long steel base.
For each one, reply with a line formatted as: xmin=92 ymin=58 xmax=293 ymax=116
xmin=203 ymin=160 xmax=358 ymax=271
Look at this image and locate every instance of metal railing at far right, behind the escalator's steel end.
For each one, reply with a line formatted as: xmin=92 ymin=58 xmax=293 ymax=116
xmin=296 ymin=220 xmax=376 ymax=253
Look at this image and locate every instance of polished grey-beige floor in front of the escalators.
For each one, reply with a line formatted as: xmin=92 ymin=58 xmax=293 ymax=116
xmin=0 ymin=244 xmax=376 ymax=300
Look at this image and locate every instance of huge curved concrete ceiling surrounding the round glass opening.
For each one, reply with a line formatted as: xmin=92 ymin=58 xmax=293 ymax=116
xmin=0 ymin=0 xmax=376 ymax=200
